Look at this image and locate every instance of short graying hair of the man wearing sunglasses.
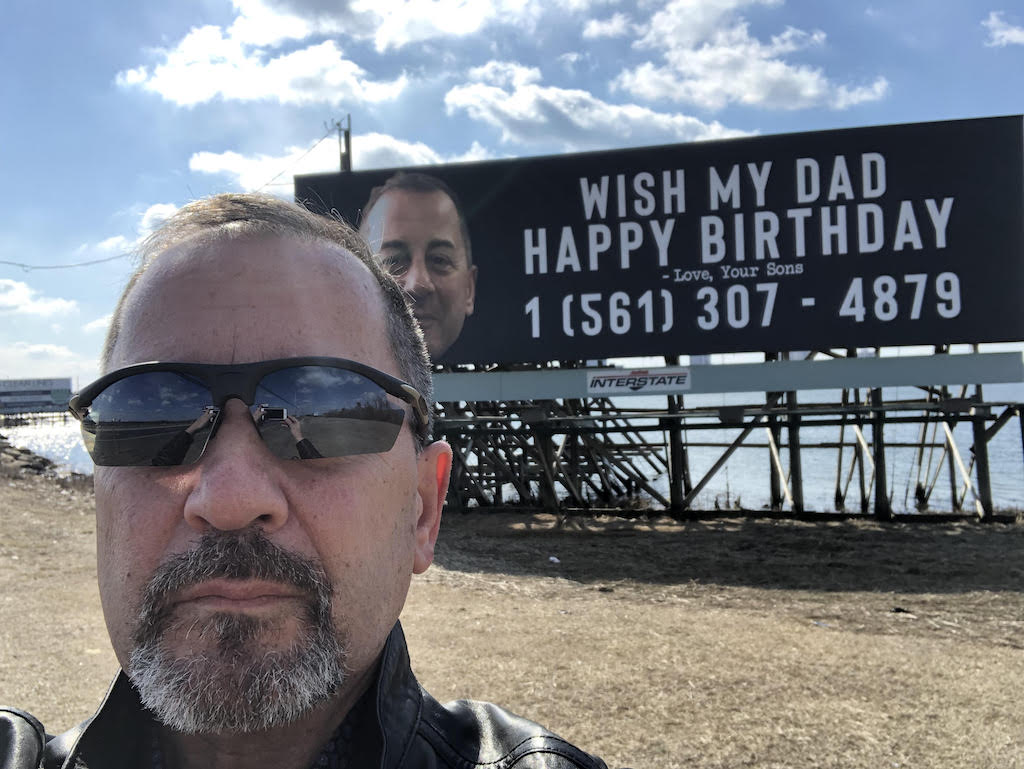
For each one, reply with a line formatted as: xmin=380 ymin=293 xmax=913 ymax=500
xmin=101 ymin=193 xmax=433 ymax=446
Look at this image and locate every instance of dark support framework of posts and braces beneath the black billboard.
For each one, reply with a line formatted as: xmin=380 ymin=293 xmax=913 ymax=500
xmin=437 ymin=351 xmax=1024 ymax=521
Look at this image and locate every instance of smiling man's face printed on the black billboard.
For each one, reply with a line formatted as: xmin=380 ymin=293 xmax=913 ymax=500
xmin=362 ymin=189 xmax=476 ymax=358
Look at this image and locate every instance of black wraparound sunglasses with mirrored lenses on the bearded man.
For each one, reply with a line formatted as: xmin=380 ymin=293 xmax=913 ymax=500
xmin=69 ymin=357 xmax=430 ymax=467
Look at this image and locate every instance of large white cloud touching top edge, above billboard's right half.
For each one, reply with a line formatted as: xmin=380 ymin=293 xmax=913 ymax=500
xmin=611 ymin=0 xmax=889 ymax=110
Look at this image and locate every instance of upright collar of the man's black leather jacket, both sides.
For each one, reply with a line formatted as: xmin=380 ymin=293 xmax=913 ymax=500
xmin=45 ymin=623 xmax=423 ymax=769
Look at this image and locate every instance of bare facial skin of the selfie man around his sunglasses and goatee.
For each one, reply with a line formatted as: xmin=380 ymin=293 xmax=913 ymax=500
xmin=95 ymin=240 xmax=447 ymax=733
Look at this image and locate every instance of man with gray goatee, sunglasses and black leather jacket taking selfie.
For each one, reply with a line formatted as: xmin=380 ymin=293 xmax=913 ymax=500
xmin=0 ymin=195 xmax=604 ymax=769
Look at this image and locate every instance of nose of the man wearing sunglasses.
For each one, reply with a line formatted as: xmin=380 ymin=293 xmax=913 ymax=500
xmin=184 ymin=399 xmax=289 ymax=531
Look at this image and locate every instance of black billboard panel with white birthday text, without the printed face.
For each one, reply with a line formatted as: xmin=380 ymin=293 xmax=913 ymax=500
xmin=296 ymin=116 xmax=1024 ymax=362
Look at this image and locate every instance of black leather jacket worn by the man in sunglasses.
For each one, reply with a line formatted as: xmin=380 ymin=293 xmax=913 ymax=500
xmin=0 ymin=624 xmax=607 ymax=769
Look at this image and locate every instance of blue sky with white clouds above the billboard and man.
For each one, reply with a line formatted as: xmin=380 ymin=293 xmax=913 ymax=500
xmin=0 ymin=0 xmax=1024 ymax=384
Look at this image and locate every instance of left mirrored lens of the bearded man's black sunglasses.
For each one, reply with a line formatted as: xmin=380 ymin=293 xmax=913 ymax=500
xmin=82 ymin=372 xmax=213 ymax=467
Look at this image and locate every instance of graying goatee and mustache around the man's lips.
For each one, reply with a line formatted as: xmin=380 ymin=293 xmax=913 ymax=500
xmin=122 ymin=528 xmax=348 ymax=734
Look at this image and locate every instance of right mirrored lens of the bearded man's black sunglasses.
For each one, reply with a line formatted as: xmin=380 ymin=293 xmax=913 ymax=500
xmin=254 ymin=366 xmax=406 ymax=459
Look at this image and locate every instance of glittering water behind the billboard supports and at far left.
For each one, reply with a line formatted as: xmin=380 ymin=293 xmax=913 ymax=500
xmin=8 ymin=384 xmax=1024 ymax=512
